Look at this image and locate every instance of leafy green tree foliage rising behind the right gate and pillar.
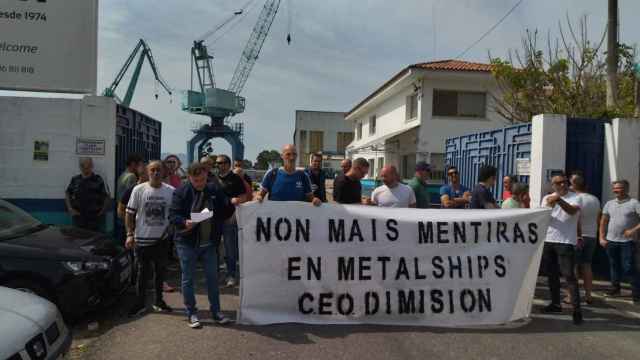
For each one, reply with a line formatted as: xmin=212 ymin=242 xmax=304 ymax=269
xmin=489 ymin=16 xmax=635 ymax=123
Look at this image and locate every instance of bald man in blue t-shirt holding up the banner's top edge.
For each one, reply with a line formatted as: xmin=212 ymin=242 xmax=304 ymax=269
xmin=256 ymin=144 xmax=322 ymax=206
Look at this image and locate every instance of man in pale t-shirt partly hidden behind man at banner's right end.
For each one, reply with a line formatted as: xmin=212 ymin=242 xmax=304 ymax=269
xmin=571 ymin=174 xmax=602 ymax=304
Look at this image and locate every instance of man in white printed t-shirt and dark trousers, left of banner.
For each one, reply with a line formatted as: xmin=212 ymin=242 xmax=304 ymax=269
xmin=125 ymin=161 xmax=174 ymax=316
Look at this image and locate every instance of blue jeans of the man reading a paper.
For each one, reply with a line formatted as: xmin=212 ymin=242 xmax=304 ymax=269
xmin=176 ymin=243 xmax=220 ymax=316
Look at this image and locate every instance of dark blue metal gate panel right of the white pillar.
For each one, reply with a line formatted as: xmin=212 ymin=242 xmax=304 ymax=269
xmin=565 ymin=118 xmax=606 ymax=200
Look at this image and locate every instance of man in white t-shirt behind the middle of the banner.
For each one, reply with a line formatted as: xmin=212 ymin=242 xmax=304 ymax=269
xmin=371 ymin=165 xmax=416 ymax=208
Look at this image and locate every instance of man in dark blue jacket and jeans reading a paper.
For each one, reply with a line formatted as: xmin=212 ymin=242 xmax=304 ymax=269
xmin=169 ymin=163 xmax=234 ymax=328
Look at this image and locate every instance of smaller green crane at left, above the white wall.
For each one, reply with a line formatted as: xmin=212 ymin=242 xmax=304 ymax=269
xmin=102 ymin=39 xmax=171 ymax=107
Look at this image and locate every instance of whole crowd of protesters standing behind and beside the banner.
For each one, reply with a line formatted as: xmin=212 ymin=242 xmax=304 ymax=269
xmin=66 ymin=145 xmax=640 ymax=328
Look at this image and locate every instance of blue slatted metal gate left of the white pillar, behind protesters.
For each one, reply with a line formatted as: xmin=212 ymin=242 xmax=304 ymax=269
xmin=445 ymin=123 xmax=531 ymax=199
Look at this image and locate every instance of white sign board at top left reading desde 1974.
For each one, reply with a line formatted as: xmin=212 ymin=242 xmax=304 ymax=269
xmin=0 ymin=0 xmax=98 ymax=93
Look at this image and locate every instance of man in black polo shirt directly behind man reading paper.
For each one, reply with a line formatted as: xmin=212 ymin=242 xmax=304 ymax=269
xmin=216 ymin=155 xmax=248 ymax=286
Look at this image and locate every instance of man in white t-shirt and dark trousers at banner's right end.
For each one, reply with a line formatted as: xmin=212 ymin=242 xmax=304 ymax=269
xmin=542 ymin=174 xmax=582 ymax=325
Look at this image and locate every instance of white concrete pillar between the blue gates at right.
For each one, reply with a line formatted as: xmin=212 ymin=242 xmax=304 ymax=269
xmin=529 ymin=114 xmax=567 ymax=208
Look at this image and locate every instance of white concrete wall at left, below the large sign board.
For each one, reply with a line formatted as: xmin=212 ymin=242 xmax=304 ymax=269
xmin=0 ymin=96 xmax=116 ymax=224
